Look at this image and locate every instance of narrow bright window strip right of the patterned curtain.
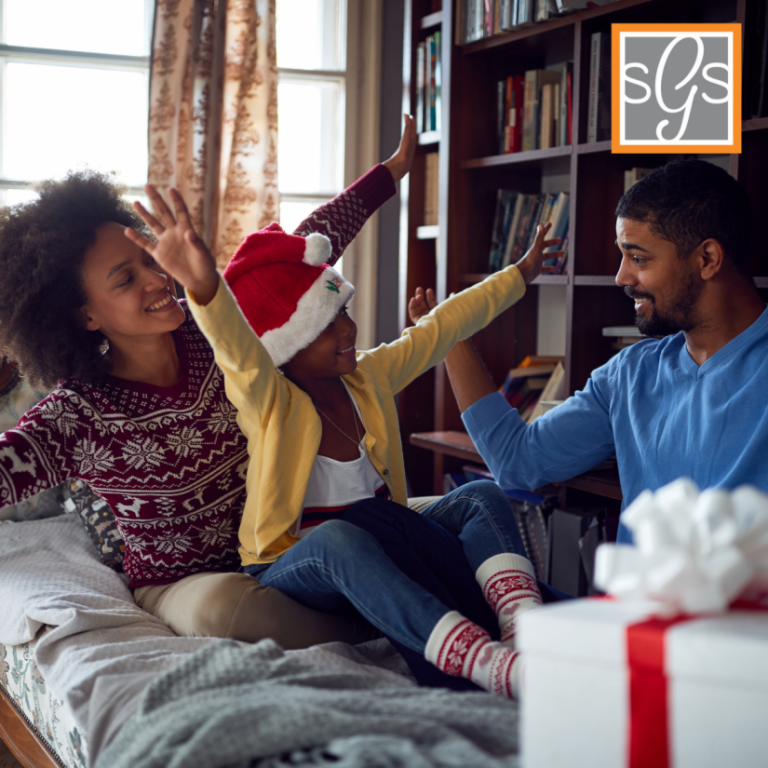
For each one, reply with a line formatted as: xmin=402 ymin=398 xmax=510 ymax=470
xmin=276 ymin=0 xmax=347 ymax=232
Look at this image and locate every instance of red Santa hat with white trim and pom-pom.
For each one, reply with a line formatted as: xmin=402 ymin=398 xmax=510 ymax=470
xmin=224 ymin=224 xmax=355 ymax=367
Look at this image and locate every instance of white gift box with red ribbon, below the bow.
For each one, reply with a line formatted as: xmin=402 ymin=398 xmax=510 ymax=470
xmin=518 ymin=599 xmax=768 ymax=768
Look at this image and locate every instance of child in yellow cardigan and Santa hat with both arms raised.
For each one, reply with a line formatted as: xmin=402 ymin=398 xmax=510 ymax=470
xmin=125 ymin=172 xmax=557 ymax=696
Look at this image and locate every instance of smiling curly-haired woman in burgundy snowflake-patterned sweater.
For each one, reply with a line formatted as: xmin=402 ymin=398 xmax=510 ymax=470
xmin=0 ymin=130 xmax=415 ymax=648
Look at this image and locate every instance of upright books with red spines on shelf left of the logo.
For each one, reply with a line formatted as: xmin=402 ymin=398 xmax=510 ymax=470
xmin=496 ymin=61 xmax=573 ymax=155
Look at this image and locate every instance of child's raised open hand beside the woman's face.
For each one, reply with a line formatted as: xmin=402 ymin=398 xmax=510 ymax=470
xmin=125 ymin=184 xmax=219 ymax=304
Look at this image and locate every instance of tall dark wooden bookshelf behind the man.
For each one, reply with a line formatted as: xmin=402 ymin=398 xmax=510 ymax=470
xmin=398 ymin=0 xmax=768 ymax=498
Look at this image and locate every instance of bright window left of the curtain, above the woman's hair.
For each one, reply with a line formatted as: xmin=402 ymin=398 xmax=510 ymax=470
xmin=0 ymin=0 xmax=154 ymax=205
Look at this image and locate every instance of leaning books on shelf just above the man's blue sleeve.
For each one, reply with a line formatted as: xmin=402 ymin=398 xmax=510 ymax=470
xmin=499 ymin=355 xmax=565 ymax=424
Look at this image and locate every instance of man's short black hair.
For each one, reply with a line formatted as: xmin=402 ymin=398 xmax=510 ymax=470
xmin=616 ymin=159 xmax=752 ymax=276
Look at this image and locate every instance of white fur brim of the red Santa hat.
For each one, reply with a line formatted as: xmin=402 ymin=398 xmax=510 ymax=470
xmin=261 ymin=266 xmax=355 ymax=368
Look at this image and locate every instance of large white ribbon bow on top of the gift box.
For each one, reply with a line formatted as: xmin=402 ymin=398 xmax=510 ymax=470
xmin=595 ymin=478 xmax=768 ymax=615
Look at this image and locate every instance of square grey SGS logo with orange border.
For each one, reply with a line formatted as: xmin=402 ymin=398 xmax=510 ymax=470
xmin=611 ymin=24 xmax=741 ymax=154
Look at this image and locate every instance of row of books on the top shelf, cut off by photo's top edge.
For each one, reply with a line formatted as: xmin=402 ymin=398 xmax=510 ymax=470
xmin=456 ymin=0 xmax=616 ymax=45
